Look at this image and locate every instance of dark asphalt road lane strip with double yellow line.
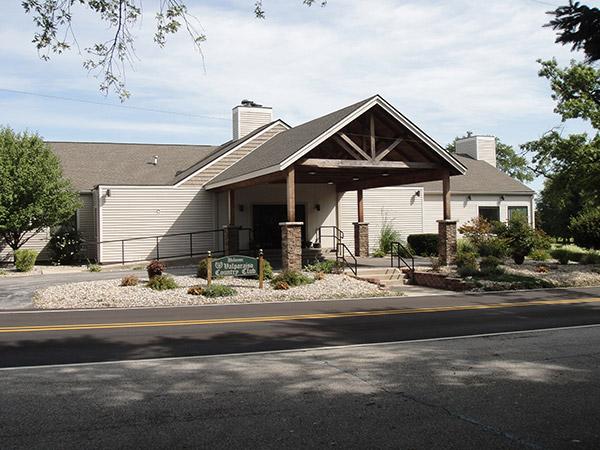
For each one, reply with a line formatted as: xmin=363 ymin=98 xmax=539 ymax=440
xmin=0 ymin=288 xmax=600 ymax=367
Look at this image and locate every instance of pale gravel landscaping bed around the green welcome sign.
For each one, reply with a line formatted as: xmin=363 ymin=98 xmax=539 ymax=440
xmin=33 ymin=275 xmax=397 ymax=309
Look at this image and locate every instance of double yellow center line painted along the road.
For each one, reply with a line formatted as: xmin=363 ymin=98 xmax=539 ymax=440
xmin=0 ymin=297 xmax=600 ymax=333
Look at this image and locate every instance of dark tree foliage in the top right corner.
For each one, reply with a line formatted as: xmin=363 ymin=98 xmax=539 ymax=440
xmin=545 ymin=0 xmax=600 ymax=62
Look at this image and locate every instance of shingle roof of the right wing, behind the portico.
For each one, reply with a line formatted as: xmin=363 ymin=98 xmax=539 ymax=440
xmin=409 ymin=155 xmax=534 ymax=194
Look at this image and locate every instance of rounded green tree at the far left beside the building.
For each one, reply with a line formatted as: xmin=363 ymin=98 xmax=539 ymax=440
xmin=0 ymin=127 xmax=80 ymax=251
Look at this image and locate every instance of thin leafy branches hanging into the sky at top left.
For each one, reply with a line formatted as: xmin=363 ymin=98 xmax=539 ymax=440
xmin=22 ymin=0 xmax=327 ymax=101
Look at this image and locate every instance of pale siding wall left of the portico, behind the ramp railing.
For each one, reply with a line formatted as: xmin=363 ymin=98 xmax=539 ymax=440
xmin=99 ymin=186 xmax=222 ymax=263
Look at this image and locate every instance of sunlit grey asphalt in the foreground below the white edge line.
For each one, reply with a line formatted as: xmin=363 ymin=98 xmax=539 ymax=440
xmin=0 ymin=324 xmax=600 ymax=449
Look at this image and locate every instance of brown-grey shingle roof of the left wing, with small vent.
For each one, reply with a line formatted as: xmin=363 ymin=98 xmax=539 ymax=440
xmin=48 ymin=142 xmax=219 ymax=191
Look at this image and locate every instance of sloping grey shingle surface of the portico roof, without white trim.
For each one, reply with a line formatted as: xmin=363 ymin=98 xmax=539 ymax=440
xmin=210 ymin=97 xmax=373 ymax=184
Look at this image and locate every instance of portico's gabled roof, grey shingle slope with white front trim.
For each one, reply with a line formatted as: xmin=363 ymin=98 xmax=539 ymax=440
xmin=207 ymin=95 xmax=466 ymax=189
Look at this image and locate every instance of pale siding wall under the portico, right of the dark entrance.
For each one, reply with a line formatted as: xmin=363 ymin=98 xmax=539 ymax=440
xmin=339 ymin=187 xmax=423 ymax=252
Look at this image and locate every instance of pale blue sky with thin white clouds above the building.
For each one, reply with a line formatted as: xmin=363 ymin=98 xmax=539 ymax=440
xmin=0 ymin=0 xmax=587 ymax=190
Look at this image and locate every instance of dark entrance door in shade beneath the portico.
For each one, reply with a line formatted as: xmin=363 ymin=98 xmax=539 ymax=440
xmin=252 ymin=205 xmax=306 ymax=249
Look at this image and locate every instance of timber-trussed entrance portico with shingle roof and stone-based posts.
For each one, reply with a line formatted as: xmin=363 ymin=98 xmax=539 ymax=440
xmin=206 ymin=96 xmax=465 ymax=270
